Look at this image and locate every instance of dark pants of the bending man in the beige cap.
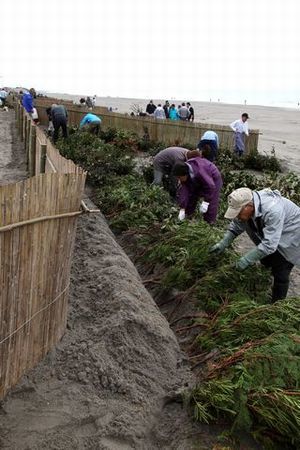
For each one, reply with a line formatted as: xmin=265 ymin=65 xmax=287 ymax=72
xmin=261 ymin=250 xmax=294 ymax=302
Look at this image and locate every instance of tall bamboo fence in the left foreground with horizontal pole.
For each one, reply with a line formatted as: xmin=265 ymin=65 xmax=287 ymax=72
xmin=0 ymin=101 xmax=86 ymax=399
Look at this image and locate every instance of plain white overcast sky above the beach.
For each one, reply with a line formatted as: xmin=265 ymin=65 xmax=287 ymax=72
xmin=0 ymin=0 xmax=300 ymax=101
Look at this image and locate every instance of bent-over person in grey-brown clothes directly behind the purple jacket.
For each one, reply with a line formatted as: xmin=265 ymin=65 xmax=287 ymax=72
xmin=152 ymin=147 xmax=200 ymax=198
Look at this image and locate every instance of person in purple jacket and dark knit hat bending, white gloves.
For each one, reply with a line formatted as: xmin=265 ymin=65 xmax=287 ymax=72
xmin=173 ymin=156 xmax=223 ymax=225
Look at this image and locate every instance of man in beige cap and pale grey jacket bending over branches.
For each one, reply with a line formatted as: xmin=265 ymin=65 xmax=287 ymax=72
xmin=211 ymin=187 xmax=300 ymax=302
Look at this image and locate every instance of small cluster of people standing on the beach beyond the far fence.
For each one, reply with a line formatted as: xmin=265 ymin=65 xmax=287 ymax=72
xmin=146 ymin=100 xmax=195 ymax=122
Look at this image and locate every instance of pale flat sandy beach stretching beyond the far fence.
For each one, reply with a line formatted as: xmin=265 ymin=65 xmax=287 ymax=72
xmin=49 ymin=93 xmax=300 ymax=173
